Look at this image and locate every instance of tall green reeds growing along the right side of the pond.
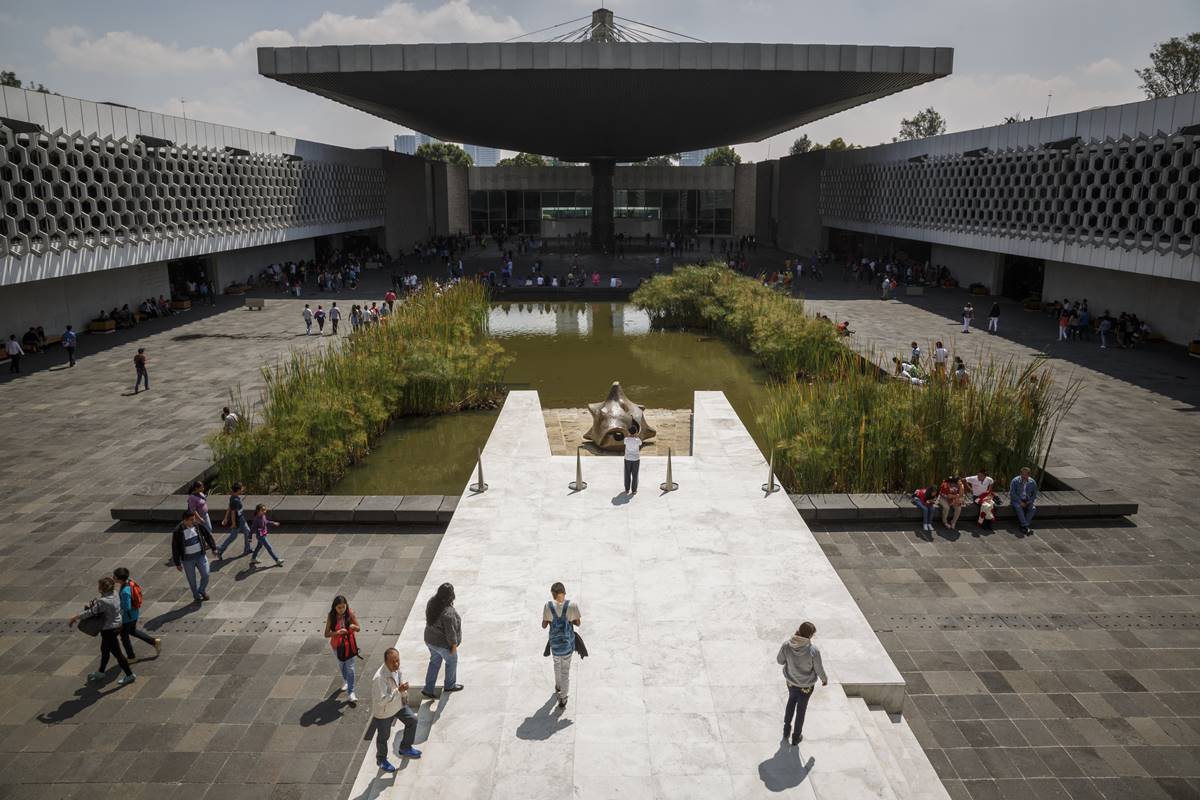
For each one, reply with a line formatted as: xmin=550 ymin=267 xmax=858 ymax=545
xmin=632 ymin=265 xmax=1079 ymax=492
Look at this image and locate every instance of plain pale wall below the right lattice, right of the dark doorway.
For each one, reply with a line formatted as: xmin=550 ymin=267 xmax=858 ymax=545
xmin=1042 ymin=261 xmax=1200 ymax=344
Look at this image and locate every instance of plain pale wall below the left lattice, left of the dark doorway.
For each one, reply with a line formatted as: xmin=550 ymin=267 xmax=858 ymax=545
xmin=0 ymin=261 xmax=170 ymax=339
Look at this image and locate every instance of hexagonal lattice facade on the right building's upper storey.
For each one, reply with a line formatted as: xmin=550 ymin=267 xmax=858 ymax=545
xmin=820 ymin=136 xmax=1200 ymax=255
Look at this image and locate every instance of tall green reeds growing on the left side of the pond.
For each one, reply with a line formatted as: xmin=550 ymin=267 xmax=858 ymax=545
xmin=210 ymin=283 xmax=511 ymax=494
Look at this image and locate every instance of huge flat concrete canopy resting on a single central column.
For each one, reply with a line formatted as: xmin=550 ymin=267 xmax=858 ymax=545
xmin=258 ymin=42 xmax=954 ymax=162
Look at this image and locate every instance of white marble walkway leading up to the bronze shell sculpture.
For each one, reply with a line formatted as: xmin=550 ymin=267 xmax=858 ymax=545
xmin=350 ymin=392 xmax=944 ymax=800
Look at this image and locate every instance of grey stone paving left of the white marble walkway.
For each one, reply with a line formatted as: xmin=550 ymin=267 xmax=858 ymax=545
xmin=0 ymin=286 xmax=444 ymax=800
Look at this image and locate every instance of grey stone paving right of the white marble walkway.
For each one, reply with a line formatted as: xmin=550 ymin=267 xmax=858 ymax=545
xmin=802 ymin=279 xmax=1200 ymax=800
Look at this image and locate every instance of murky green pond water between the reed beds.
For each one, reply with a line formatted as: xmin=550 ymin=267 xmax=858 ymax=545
xmin=330 ymin=302 xmax=767 ymax=494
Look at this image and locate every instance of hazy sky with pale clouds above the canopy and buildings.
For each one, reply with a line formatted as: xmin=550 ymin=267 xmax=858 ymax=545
xmin=0 ymin=0 xmax=1200 ymax=161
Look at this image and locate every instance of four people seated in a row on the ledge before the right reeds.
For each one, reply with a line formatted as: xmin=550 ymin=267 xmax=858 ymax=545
xmin=912 ymin=467 xmax=1038 ymax=536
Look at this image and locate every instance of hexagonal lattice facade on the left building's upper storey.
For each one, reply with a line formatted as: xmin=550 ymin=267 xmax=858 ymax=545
xmin=0 ymin=126 xmax=385 ymax=258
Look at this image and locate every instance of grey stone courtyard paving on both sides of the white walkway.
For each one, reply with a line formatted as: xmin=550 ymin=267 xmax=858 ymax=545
xmin=0 ymin=253 xmax=1200 ymax=800
